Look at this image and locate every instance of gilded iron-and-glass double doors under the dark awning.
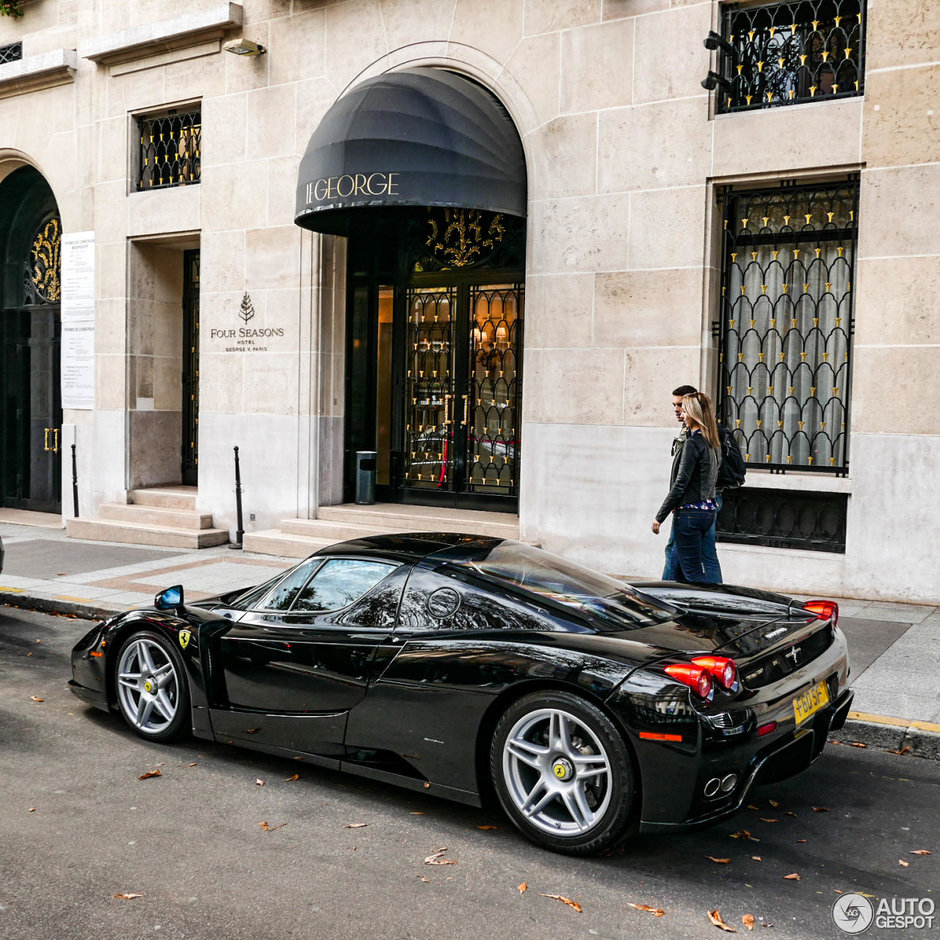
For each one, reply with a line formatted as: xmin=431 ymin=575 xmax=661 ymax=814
xmin=400 ymin=283 xmax=523 ymax=510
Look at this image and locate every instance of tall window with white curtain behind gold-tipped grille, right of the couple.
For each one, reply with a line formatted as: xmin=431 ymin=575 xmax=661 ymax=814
xmin=716 ymin=180 xmax=858 ymax=476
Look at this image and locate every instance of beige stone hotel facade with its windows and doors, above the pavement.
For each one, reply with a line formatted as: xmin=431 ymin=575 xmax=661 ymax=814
xmin=0 ymin=0 xmax=940 ymax=602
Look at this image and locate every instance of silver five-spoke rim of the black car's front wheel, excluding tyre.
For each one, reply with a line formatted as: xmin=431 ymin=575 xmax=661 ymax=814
xmin=117 ymin=637 xmax=180 ymax=735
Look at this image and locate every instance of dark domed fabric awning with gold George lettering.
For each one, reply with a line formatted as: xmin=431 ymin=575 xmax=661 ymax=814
xmin=294 ymin=68 xmax=526 ymax=234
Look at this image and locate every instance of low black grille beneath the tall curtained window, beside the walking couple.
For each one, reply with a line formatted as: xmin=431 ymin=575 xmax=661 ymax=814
xmin=718 ymin=487 xmax=848 ymax=554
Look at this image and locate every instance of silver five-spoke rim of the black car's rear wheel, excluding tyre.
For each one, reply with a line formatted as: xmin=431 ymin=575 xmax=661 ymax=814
xmin=503 ymin=708 xmax=611 ymax=837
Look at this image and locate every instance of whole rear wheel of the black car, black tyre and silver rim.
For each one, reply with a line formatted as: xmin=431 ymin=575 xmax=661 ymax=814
xmin=490 ymin=692 xmax=635 ymax=855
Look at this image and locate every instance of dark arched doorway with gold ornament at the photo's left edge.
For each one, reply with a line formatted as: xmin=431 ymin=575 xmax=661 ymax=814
xmin=0 ymin=167 xmax=62 ymax=513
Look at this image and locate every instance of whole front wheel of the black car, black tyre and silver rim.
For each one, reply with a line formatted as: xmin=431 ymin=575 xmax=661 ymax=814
xmin=114 ymin=631 xmax=190 ymax=741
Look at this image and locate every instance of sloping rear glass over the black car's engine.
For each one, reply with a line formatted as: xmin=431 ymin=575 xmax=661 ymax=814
xmin=456 ymin=541 xmax=673 ymax=630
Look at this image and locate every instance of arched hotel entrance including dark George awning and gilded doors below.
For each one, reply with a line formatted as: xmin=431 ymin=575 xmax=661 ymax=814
xmin=295 ymin=68 xmax=526 ymax=512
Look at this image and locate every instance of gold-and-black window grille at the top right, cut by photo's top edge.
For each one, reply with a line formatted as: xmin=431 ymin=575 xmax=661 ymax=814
xmin=718 ymin=0 xmax=865 ymax=113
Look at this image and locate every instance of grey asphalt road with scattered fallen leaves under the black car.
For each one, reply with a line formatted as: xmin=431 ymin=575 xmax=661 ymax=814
xmin=0 ymin=608 xmax=940 ymax=940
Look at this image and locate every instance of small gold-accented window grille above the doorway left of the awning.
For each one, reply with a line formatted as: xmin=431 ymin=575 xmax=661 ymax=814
xmin=137 ymin=109 xmax=202 ymax=191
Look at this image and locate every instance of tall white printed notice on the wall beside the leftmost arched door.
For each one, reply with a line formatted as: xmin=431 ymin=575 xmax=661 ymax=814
xmin=60 ymin=232 xmax=95 ymax=410
